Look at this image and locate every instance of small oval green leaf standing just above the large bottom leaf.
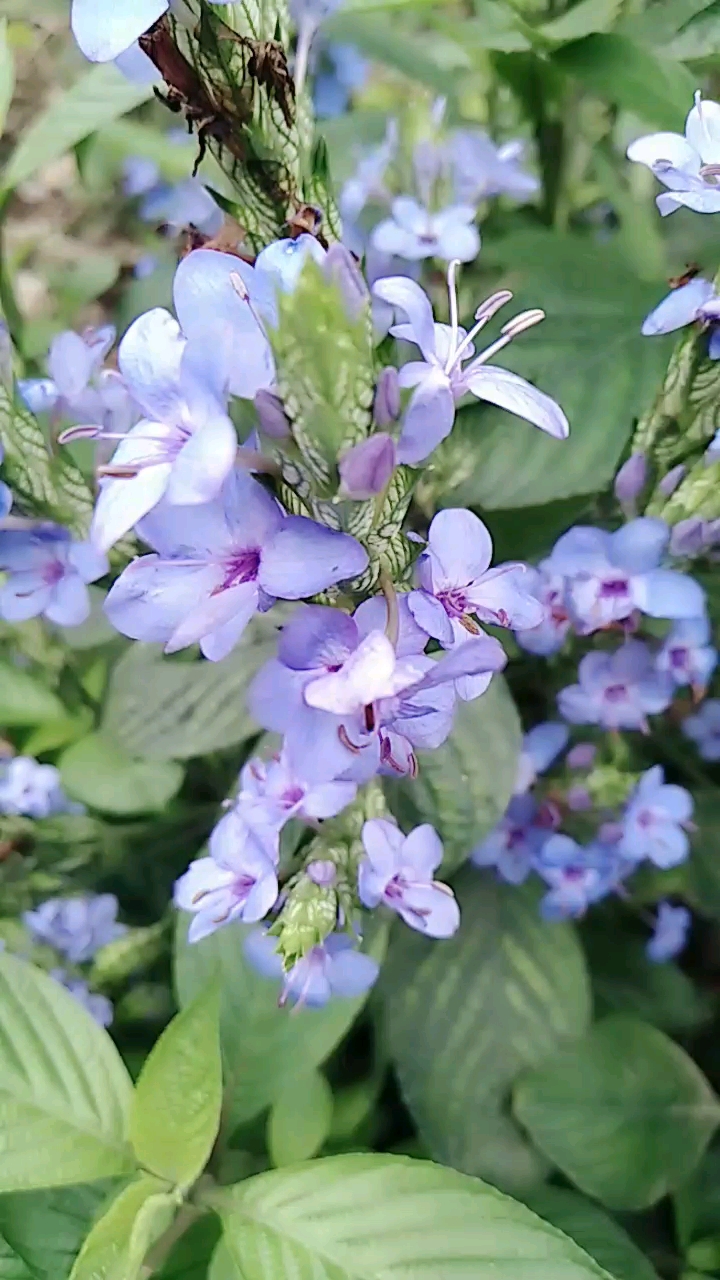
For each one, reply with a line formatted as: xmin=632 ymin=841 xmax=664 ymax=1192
xmin=268 ymin=1071 xmax=333 ymax=1169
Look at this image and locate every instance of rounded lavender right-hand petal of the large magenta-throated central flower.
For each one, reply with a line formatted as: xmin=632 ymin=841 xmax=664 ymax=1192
xmin=258 ymin=516 xmax=368 ymax=600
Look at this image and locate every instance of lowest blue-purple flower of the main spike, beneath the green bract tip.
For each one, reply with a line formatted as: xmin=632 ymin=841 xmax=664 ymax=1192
xmin=245 ymin=929 xmax=379 ymax=1009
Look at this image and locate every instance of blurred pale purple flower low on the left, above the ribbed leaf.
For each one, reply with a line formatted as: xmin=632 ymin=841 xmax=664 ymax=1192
xmin=23 ymin=893 xmax=127 ymax=964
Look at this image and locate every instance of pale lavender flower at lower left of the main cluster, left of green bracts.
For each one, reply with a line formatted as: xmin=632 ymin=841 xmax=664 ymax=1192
xmin=174 ymin=810 xmax=278 ymax=942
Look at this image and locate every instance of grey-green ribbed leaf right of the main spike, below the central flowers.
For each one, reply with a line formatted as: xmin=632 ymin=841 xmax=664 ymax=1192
xmin=383 ymin=676 xmax=521 ymax=873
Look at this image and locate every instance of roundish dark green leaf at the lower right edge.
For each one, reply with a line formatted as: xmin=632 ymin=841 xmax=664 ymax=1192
xmin=515 ymin=1015 xmax=720 ymax=1210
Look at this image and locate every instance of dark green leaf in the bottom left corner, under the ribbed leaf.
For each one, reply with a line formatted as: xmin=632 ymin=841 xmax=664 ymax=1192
xmin=0 ymin=1183 xmax=117 ymax=1280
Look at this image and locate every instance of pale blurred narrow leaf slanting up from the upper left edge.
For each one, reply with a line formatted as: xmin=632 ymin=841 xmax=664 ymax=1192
xmin=1 ymin=63 xmax=152 ymax=191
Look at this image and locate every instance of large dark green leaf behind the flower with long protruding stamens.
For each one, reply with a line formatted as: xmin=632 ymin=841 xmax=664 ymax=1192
xmin=424 ymin=230 xmax=670 ymax=511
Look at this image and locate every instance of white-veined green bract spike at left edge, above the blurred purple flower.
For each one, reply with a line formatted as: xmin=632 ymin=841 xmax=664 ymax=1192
xmin=0 ymin=384 xmax=94 ymax=536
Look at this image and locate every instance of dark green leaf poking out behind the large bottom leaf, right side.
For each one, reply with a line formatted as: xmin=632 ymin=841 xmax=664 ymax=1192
xmin=525 ymin=1187 xmax=657 ymax=1280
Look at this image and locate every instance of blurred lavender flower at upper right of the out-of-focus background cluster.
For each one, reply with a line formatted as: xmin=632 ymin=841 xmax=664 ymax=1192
xmin=447 ymin=129 xmax=541 ymax=205
